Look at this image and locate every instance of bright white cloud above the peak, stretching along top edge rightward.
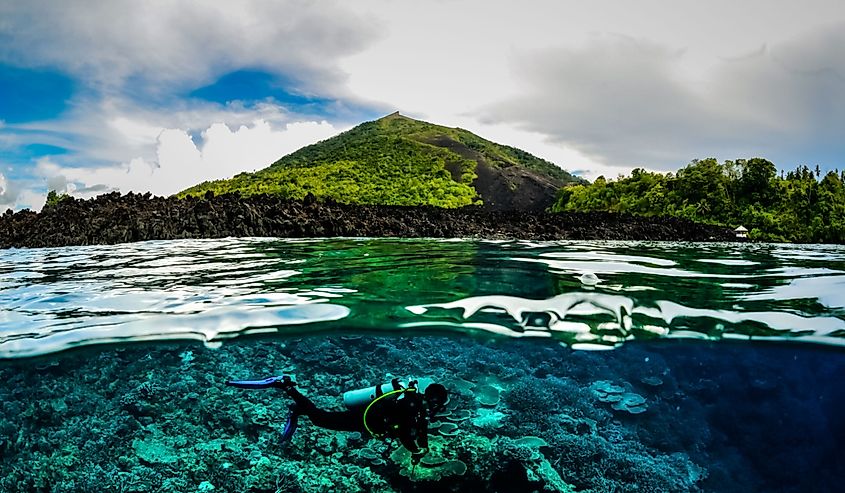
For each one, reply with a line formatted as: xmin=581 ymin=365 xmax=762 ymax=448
xmin=340 ymin=0 xmax=845 ymax=112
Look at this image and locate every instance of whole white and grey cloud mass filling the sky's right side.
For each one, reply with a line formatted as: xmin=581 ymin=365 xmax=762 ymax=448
xmin=341 ymin=0 xmax=845 ymax=177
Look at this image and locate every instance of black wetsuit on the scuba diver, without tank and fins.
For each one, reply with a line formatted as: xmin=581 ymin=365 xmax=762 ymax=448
xmin=285 ymin=387 xmax=428 ymax=453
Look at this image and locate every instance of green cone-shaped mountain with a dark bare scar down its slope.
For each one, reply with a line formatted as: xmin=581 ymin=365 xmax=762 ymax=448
xmin=178 ymin=113 xmax=583 ymax=210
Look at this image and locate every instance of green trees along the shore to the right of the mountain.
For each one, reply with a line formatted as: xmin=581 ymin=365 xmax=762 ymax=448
xmin=552 ymin=158 xmax=845 ymax=243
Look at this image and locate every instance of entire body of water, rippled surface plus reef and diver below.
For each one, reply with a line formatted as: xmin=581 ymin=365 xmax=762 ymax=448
xmin=0 ymin=238 xmax=845 ymax=493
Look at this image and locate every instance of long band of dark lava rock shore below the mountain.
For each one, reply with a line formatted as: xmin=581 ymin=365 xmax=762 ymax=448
xmin=0 ymin=192 xmax=735 ymax=248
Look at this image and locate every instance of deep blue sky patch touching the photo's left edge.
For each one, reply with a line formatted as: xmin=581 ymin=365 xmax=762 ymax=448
xmin=0 ymin=64 xmax=74 ymax=123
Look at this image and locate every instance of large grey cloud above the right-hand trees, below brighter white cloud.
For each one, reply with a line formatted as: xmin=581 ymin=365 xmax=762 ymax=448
xmin=481 ymin=25 xmax=845 ymax=169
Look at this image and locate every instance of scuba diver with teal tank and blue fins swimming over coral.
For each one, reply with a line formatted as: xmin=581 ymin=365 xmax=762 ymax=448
xmin=226 ymin=375 xmax=448 ymax=465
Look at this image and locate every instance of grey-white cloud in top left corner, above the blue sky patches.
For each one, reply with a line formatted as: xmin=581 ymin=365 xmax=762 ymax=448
xmin=0 ymin=0 xmax=380 ymax=94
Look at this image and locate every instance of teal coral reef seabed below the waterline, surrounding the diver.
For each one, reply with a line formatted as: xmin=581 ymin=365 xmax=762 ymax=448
xmin=0 ymin=337 xmax=845 ymax=493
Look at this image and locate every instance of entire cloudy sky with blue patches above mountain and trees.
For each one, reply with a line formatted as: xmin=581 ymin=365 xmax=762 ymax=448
xmin=0 ymin=0 xmax=845 ymax=211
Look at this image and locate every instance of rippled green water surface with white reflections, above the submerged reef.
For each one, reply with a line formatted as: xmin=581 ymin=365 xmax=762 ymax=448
xmin=0 ymin=239 xmax=845 ymax=359
